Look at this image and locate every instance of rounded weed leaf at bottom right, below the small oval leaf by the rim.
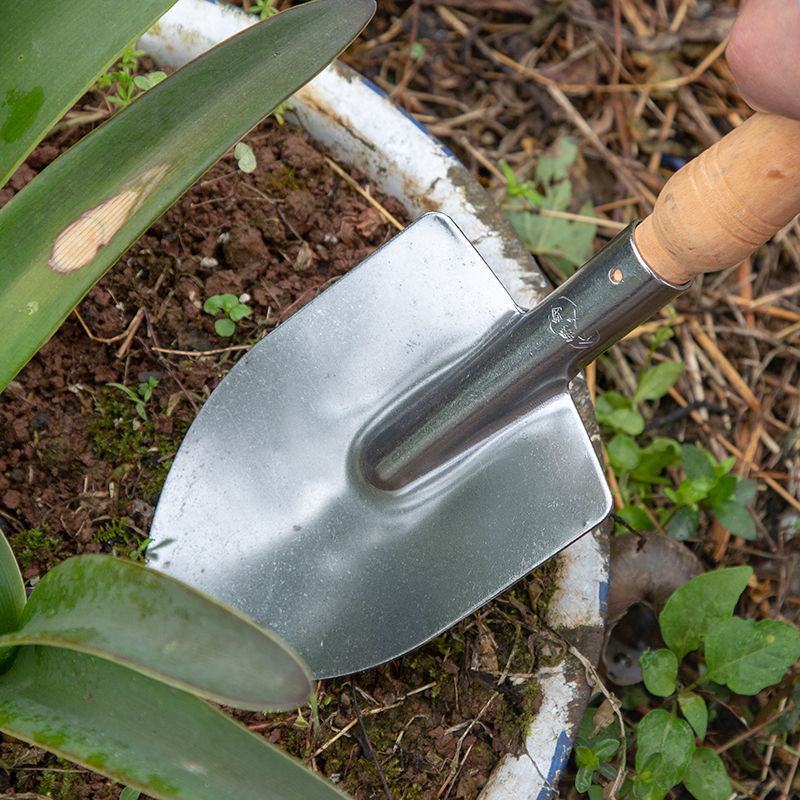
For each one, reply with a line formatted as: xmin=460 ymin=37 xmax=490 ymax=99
xmin=636 ymin=708 xmax=694 ymax=791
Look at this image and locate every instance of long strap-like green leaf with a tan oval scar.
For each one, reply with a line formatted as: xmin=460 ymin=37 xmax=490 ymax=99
xmin=0 ymin=0 xmax=375 ymax=389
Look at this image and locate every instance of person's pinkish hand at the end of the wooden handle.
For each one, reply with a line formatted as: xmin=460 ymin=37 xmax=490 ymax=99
xmin=726 ymin=0 xmax=800 ymax=119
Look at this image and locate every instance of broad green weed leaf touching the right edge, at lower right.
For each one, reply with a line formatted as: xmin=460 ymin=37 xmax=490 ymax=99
xmin=705 ymin=617 xmax=800 ymax=694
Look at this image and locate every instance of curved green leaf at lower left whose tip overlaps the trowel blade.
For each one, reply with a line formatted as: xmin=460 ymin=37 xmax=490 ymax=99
xmin=0 ymin=555 xmax=311 ymax=710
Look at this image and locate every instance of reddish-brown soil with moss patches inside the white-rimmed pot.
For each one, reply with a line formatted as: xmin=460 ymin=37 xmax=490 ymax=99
xmin=0 ymin=92 xmax=553 ymax=800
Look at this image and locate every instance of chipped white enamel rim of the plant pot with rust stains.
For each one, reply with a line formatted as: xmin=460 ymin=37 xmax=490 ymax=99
xmin=139 ymin=0 xmax=608 ymax=800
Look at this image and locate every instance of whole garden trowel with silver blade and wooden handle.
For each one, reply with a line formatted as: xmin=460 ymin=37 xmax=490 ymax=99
xmin=148 ymin=114 xmax=800 ymax=677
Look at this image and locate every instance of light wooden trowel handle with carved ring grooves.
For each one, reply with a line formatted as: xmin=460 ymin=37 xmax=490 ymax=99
xmin=634 ymin=112 xmax=800 ymax=285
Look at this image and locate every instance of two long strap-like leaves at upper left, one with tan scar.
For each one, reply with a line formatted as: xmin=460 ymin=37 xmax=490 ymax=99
xmin=0 ymin=0 xmax=375 ymax=391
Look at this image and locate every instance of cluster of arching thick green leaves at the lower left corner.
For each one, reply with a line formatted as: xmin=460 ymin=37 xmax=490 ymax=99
xmin=0 ymin=534 xmax=344 ymax=800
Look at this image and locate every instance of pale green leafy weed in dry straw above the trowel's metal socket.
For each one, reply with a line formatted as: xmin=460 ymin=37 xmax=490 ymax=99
xmin=500 ymin=136 xmax=596 ymax=275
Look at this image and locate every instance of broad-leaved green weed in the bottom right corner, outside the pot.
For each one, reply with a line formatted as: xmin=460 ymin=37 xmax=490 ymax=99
xmin=575 ymin=567 xmax=800 ymax=800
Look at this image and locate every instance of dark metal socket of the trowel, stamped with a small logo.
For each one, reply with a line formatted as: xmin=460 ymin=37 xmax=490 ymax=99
xmin=360 ymin=223 xmax=689 ymax=490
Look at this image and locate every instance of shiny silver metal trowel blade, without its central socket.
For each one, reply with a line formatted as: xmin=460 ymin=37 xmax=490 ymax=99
xmin=148 ymin=214 xmax=611 ymax=677
